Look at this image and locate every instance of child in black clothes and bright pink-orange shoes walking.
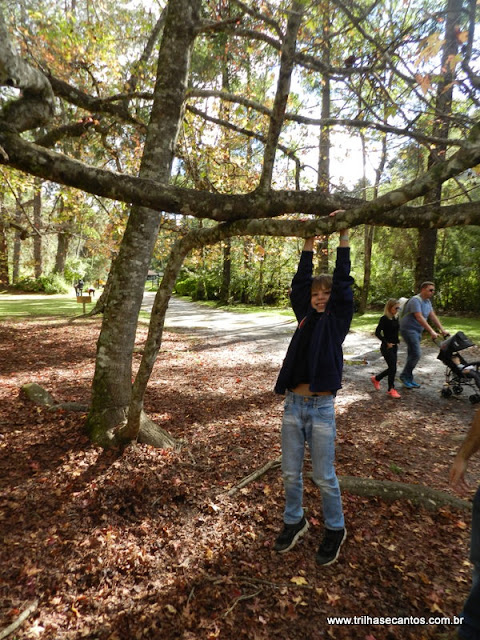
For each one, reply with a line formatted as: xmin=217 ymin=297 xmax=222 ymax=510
xmin=370 ymin=298 xmax=401 ymax=398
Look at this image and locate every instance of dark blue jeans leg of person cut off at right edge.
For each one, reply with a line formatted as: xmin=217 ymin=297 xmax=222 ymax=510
xmin=458 ymin=487 xmax=480 ymax=640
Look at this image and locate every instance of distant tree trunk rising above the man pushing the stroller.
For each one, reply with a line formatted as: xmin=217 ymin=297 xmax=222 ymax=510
xmin=415 ymin=0 xmax=463 ymax=291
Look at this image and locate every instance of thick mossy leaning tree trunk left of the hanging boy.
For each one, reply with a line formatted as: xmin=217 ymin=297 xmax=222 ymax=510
xmin=87 ymin=0 xmax=201 ymax=446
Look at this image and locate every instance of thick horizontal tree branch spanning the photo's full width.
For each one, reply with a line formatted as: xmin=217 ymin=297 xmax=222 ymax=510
xmin=0 ymin=125 xmax=480 ymax=226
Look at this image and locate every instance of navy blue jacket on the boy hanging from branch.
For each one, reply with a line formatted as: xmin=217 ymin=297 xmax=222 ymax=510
xmin=275 ymin=247 xmax=353 ymax=395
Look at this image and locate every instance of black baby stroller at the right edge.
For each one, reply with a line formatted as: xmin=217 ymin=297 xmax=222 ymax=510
xmin=437 ymin=331 xmax=480 ymax=404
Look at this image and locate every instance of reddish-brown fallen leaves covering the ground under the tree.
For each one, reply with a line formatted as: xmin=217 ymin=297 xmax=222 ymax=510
xmin=0 ymin=320 xmax=480 ymax=640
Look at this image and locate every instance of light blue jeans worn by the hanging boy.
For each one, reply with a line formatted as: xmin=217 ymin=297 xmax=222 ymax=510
xmin=282 ymin=391 xmax=345 ymax=529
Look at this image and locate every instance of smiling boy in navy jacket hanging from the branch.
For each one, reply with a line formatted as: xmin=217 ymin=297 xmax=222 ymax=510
xmin=274 ymin=231 xmax=353 ymax=565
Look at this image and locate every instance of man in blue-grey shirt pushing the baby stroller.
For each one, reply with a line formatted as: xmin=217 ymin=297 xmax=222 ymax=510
xmin=400 ymin=282 xmax=448 ymax=389
